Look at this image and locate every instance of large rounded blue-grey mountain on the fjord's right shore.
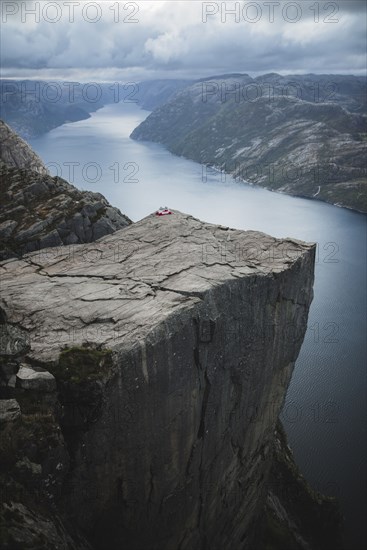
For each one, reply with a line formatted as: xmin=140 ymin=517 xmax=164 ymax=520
xmin=131 ymin=74 xmax=367 ymax=212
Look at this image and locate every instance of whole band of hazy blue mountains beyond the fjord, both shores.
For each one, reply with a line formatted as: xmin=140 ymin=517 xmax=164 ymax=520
xmin=0 ymin=73 xmax=367 ymax=212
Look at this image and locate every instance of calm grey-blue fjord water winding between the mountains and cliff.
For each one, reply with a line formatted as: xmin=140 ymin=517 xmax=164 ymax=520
xmin=31 ymin=103 xmax=367 ymax=550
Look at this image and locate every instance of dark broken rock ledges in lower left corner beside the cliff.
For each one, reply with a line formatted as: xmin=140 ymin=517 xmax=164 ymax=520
xmin=0 ymin=308 xmax=90 ymax=550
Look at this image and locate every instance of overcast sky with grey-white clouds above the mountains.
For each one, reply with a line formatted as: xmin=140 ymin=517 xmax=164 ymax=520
xmin=1 ymin=0 xmax=366 ymax=81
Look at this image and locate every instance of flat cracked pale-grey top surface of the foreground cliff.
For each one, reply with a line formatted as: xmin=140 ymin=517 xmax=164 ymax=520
xmin=0 ymin=211 xmax=312 ymax=361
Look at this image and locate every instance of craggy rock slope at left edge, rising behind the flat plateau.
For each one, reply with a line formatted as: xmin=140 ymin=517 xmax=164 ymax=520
xmin=0 ymin=122 xmax=131 ymax=259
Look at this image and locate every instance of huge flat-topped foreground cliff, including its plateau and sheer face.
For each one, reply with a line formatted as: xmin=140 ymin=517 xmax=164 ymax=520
xmin=0 ymin=212 xmax=336 ymax=550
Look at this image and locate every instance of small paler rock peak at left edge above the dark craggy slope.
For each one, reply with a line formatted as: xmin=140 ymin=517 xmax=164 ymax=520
xmin=0 ymin=120 xmax=48 ymax=175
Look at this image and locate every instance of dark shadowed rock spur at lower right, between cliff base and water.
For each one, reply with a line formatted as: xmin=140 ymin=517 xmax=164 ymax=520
xmin=257 ymin=422 xmax=343 ymax=550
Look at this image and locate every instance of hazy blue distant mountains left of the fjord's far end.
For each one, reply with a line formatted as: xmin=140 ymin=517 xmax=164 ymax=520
xmin=0 ymin=80 xmax=193 ymax=139
